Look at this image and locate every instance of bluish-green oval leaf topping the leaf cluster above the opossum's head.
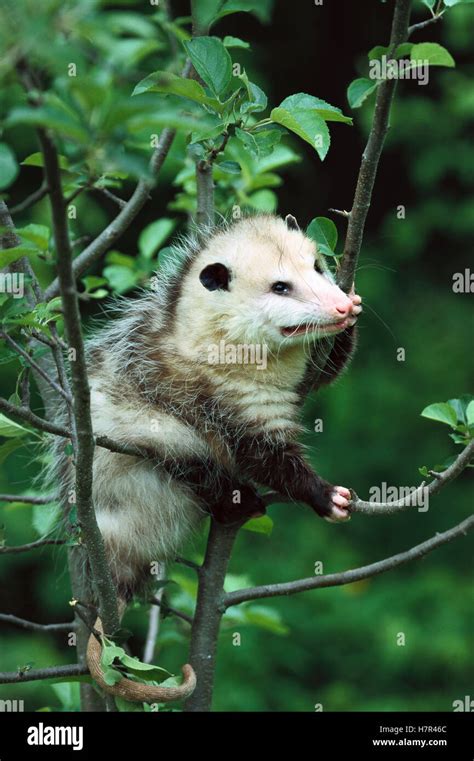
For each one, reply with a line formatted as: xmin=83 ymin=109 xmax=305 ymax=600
xmin=183 ymin=37 xmax=232 ymax=96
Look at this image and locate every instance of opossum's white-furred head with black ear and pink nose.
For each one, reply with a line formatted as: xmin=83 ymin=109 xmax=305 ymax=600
xmin=175 ymin=216 xmax=352 ymax=349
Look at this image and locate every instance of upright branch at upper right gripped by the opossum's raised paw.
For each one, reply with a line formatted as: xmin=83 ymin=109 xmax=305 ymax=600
xmin=338 ymin=0 xmax=411 ymax=292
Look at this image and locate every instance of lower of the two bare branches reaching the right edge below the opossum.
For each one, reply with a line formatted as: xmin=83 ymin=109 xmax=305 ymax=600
xmin=224 ymin=515 xmax=474 ymax=608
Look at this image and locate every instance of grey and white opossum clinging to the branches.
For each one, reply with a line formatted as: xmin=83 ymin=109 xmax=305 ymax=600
xmin=63 ymin=215 xmax=362 ymax=700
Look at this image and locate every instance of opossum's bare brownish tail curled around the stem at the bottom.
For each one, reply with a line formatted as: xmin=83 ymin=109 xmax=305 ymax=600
xmin=87 ymin=600 xmax=196 ymax=703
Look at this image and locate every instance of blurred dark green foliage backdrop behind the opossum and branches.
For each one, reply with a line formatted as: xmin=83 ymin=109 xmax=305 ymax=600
xmin=0 ymin=0 xmax=474 ymax=711
